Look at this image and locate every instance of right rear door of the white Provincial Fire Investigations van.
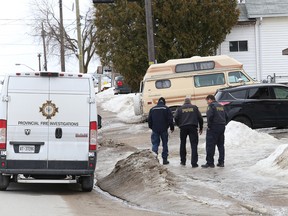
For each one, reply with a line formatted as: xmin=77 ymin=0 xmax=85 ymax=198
xmin=47 ymin=77 xmax=90 ymax=169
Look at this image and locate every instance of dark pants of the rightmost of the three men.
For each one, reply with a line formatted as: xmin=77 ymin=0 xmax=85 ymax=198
xmin=206 ymin=125 xmax=225 ymax=165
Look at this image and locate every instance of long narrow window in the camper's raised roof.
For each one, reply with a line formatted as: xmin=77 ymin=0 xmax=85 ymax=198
xmin=175 ymin=61 xmax=215 ymax=73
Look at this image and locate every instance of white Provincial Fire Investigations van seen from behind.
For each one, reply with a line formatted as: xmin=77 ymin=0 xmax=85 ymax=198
xmin=0 ymin=72 xmax=98 ymax=191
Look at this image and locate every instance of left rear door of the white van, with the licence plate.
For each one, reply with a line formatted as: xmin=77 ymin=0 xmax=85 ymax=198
xmin=6 ymin=76 xmax=49 ymax=169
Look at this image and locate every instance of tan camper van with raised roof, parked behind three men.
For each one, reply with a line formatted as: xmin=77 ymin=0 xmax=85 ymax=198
xmin=134 ymin=55 xmax=255 ymax=116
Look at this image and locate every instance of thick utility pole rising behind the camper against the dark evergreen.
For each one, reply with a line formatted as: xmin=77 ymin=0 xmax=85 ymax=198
xmin=145 ymin=0 xmax=155 ymax=65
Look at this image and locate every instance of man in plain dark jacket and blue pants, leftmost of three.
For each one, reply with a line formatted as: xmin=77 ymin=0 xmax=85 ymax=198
xmin=148 ymin=97 xmax=174 ymax=165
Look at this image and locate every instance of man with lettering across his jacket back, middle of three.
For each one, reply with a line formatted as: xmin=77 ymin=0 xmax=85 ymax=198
xmin=174 ymin=98 xmax=203 ymax=168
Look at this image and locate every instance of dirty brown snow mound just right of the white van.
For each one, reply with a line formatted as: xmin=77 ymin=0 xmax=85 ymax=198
xmin=97 ymin=150 xmax=176 ymax=198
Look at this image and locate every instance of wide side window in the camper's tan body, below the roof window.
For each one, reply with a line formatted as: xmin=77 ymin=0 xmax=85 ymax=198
xmin=194 ymin=73 xmax=225 ymax=87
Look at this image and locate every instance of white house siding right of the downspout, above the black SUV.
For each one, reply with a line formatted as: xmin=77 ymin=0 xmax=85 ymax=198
xmin=259 ymin=17 xmax=288 ymax=82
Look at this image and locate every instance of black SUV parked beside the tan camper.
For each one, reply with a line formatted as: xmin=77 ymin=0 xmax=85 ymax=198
xmin=215 ymin=84 xmax=288 ymax=128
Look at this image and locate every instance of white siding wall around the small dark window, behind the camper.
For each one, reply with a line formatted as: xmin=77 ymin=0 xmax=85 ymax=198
xmin=217 ymin=24 xmax=258 ymax=79
